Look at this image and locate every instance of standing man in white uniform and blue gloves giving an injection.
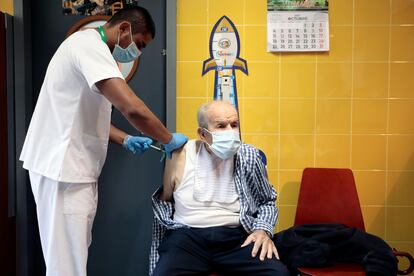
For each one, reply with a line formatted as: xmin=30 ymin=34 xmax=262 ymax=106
xmin=20 ymin=7 xmax=187 ymax=276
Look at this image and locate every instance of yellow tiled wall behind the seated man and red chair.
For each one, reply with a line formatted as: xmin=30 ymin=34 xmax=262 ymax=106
xmin=177 ymin=0 xmax=414 ymax=253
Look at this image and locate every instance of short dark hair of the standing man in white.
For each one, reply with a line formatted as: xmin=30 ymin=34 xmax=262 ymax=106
xmin=108 ymin=6 xmax=155 ymax=38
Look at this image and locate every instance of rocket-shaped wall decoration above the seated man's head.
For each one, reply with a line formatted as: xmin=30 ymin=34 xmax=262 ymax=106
xmin=202 ymin=16 xmax=248 ymax=109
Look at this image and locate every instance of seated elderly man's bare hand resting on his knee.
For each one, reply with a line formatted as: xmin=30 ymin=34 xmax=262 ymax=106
xmin=241 ymin=230 xmax=279 ymax=261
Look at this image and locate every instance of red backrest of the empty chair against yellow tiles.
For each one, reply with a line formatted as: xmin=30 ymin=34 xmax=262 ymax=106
xmin=295 ymin=168 xmax=365 ymax=231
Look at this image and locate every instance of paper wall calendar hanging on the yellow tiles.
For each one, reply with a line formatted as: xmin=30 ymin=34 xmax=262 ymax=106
xmin=267 ymin=0 xmax=329 ymax=52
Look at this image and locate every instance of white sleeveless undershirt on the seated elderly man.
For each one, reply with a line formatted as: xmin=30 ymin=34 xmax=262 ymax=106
xmin=173 ymin=140 xmax=240 ymax=228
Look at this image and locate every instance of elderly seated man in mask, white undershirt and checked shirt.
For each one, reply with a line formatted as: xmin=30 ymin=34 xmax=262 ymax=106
xmin=150 ymin=101 xmax=289 ymax=276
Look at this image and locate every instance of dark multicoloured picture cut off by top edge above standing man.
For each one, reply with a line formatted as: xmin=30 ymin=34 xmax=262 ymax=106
xmin=62 ymin=0 xmax=138 ymax=15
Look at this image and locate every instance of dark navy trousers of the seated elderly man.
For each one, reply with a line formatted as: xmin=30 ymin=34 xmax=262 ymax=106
xmin=153 ymin=227 xmax=290 ymax=276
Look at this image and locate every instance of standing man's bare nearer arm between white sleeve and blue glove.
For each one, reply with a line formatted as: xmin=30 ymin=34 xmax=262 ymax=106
xmin=96 ymin=78 xmax=172 ymax=144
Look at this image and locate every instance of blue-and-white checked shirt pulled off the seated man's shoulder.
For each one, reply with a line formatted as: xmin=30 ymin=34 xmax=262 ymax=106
xmin=149 ymin=141 xmax=278 ymax=275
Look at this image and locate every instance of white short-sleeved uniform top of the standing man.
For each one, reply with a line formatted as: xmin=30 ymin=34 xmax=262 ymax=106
xmin=20 ymin=29 xmax=124 ymax=183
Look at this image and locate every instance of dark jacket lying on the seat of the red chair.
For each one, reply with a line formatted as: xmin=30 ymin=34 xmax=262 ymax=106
xmin=274 ymin=223 xmax=397 ymax=276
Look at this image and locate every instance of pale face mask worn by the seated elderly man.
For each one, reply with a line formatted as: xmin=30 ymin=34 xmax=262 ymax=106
xmin=204 ymin=129 xmax=241 ymax=160
